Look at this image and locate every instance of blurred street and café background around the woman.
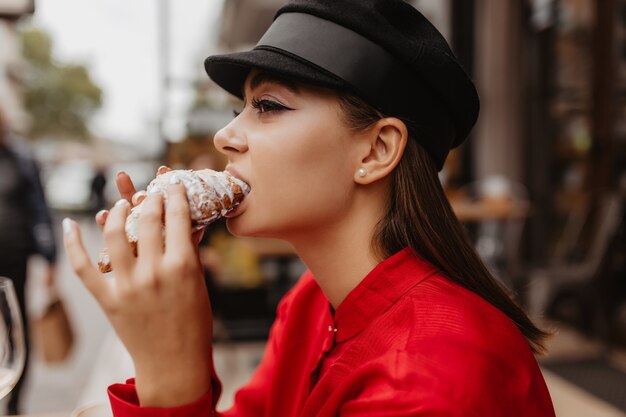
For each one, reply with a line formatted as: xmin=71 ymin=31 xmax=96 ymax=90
xmin=0 ymin=0 xmax=626 ymax=417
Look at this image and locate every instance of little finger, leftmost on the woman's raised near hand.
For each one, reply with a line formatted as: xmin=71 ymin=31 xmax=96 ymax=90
xmin=63 ymin=218 xmax=110 ymax=303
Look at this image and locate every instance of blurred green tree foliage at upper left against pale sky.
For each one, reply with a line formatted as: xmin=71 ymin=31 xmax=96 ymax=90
xmin=20 ymin=27 xmax=102 ymax=140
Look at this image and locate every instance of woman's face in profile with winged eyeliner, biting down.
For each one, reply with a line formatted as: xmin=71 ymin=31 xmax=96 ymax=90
xmin=214 ymin=71 xmax=358 ymax=239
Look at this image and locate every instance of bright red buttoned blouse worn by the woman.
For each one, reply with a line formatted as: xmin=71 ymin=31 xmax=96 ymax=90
xmin=109 ymin=249 xmax=554 ymax=417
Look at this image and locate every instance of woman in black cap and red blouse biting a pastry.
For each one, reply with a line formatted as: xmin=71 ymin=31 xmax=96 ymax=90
xmin=64 ymin=0 xmax=554 ymax=417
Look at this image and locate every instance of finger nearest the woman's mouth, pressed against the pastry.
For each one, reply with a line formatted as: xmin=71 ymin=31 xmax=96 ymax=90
xmin=165 ymin=184 xmax=193 ymax=253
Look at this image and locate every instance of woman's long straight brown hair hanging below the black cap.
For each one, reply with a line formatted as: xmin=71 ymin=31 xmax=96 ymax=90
xmin=339 ymin=94 xmax=548 ymax=353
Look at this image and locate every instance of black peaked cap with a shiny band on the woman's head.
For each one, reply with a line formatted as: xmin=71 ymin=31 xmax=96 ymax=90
xmin=204 ymin=0 xmax=479 ymax=169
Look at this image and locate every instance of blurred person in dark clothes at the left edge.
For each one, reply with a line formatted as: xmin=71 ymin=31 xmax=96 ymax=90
xmin=0 ymin=109 xmax=56 ymax=414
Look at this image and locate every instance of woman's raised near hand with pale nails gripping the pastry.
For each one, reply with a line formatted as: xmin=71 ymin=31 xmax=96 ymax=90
xmin=64 ymin=180 xmax=212 ymax=407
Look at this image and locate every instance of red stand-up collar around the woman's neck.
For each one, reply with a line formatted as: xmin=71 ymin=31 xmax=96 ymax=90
xmin=335 ymin=248 xmax=436 ymax=343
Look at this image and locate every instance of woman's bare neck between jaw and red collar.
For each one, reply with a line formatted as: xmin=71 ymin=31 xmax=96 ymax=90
xmin=289 ymin=185 xmax=385 ymax=309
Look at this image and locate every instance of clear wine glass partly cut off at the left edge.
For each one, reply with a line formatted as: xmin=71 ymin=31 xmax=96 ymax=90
xmin=0 ymin=277 xmax=26 ymax=399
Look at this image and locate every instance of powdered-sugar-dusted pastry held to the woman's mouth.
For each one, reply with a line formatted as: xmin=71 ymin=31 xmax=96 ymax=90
xmin=98 ymin=167 xmax=250 ymax=272
